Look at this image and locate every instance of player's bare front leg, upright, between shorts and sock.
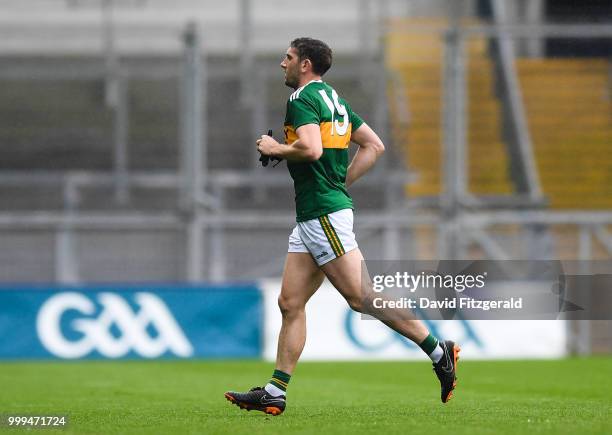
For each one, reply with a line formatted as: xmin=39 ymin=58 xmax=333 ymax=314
xmin=276 ymin=252 xmax=325 ymax=374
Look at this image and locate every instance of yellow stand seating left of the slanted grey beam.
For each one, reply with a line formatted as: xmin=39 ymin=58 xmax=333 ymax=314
xmin=387 ymin=19 xmax=513 ymax=197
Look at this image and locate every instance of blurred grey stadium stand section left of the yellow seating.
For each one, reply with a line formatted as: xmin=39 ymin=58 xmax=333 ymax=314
xmin=0 ymin=0 xmax=392 ymax=282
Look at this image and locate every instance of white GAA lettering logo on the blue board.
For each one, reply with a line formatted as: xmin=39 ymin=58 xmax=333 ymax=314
xmin=36 ymin=292 xmax=193 ymax=359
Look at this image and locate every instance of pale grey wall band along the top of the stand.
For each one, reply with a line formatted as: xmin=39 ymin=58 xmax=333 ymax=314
xmin=0 ymin=0 xmax=474 ymax=55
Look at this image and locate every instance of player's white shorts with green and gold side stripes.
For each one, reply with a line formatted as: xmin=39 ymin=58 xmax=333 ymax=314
xmin=289 ymin=208 xmax=357 ymax=266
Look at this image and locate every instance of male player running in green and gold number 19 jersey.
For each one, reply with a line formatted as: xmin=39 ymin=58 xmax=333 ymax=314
xmin=225 ymin=38 xmax=459 ymax=415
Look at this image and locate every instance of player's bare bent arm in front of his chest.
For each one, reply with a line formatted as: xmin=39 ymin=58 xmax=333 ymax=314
xmin=257 ymin=124 xmax=323 ymax=162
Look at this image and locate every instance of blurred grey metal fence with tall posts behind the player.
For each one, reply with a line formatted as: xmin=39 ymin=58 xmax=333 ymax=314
xmin=0 ymin=3 xmax=612 ymax=282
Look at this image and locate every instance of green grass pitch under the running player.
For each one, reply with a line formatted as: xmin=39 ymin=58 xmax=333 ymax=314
xmin=0 ymin=358 xmax=612 ymax=435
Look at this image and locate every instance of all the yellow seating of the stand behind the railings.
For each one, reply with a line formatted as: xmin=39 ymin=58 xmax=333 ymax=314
xmin=387 ymin=19 xmax=612 ymax=209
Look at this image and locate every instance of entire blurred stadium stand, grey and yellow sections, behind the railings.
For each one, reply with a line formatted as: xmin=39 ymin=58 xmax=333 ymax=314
xmin=0 ymin=0 xmax=612 ymax=280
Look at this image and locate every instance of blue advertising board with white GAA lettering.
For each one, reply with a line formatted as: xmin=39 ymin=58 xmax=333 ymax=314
xmin=0 ymin=285 xmax=262 ymax=359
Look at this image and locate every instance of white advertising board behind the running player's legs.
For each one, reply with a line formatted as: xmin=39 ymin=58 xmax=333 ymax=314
xmin=262 ymin=280 xmax=566 ymax=360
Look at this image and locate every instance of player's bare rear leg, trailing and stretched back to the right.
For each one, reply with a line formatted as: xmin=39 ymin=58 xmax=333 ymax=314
xmin=321 ymin=248 xmax=429 ymax=344
